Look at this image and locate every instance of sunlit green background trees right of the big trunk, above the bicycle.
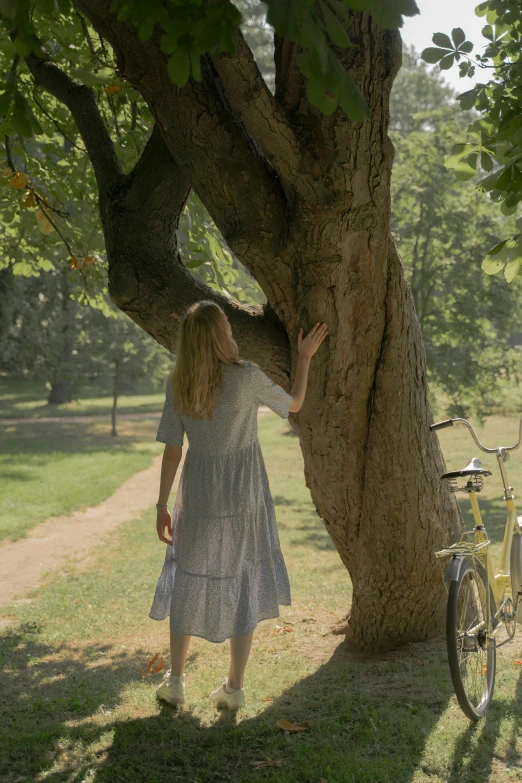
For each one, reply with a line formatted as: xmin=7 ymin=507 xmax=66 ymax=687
xmin=391 ymin=51 xmax=521 ymax=417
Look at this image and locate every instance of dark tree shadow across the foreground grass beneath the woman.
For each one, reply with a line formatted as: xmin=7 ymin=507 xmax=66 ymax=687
xmin=0 ymin=624 xmax=466 ymax=783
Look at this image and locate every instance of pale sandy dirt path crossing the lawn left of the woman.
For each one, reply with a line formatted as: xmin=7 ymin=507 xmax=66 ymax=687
xmin=0 ymin=406 xmax=270 ymax=626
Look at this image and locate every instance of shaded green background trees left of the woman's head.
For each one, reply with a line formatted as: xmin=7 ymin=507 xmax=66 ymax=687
xmin=0 ymin=266 xmax=171 ymax=410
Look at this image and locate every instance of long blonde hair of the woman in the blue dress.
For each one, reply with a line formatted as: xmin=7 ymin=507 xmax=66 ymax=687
xmin=170 ymin=299 xmax=239 ymax=419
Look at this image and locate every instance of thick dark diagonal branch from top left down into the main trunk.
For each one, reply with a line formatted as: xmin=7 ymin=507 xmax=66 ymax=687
xmin=73 ymin=0 xmax=293 ymax=301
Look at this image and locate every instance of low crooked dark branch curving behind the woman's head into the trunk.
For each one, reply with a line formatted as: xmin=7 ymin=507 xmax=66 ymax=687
xmin=107 ymin=125 xmax=290 ymax=388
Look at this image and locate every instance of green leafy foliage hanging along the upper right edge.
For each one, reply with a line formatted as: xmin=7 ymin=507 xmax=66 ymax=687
xmin=422 ymin=0 xmax=522 ymax=282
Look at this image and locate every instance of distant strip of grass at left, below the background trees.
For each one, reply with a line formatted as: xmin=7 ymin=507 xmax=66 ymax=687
xmin=0 ymin=376 xmax=165 ymax=419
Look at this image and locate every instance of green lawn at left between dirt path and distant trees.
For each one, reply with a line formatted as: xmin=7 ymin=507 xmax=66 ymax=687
xmin=0 ymin=420 xmax=162 ymax=540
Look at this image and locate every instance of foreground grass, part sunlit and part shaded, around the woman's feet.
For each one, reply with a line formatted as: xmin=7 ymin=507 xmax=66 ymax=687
xmin=0 ymin=415 xmax=522 ymax=783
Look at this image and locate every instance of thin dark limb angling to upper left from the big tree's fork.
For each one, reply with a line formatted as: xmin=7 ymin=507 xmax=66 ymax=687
xmin=26 ymin=54 xmax=122 ymax=195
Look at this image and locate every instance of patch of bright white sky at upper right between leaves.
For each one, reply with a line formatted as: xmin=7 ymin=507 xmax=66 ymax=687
xmin=401 ymin=0 xmax=487 ymax=92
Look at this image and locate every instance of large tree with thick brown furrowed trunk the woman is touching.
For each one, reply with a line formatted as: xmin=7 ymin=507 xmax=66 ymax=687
xmin=0 ymin=0 xmax=460 ymax=650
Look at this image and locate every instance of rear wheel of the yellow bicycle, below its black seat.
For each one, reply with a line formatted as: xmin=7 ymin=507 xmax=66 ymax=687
xmin=446 ymin=558 xmax=496 ymax=721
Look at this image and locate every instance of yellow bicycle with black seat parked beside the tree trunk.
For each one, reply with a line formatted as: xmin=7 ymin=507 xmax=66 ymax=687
xmin=430 ymin=416 xmax=522 ymax=721
